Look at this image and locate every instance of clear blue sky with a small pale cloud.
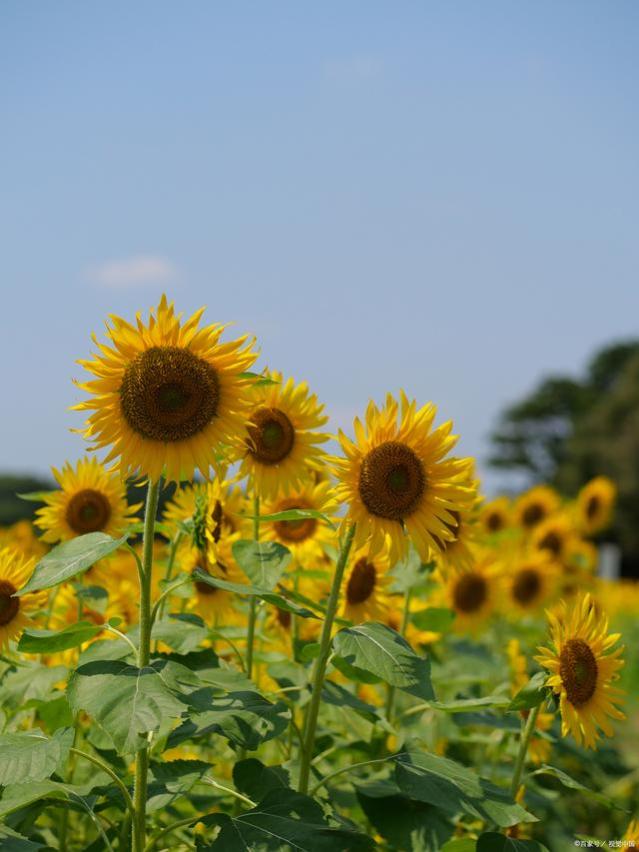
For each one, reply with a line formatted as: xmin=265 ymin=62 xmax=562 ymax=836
xmin=0 ymin=0 xmax=639 ymax=487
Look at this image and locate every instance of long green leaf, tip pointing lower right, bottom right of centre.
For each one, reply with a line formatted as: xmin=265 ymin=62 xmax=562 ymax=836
xmin=395 ymin=752 xmax=536 ymax=828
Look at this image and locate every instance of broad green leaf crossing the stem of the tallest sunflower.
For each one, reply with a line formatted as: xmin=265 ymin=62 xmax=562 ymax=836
xmin=67 ymin=660 xmax=185 ymax=754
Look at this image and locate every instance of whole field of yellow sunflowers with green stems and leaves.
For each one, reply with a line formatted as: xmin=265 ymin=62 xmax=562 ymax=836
xmin=0 ymin=297 xmax=639 ymax=852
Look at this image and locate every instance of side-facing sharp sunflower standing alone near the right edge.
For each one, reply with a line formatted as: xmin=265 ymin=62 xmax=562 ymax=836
xmin=535 ymin=594 xmax=625 ymax=748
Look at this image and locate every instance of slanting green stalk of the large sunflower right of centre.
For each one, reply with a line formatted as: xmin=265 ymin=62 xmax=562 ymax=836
xmin=299 ymin=524 xmax=355 ymax=793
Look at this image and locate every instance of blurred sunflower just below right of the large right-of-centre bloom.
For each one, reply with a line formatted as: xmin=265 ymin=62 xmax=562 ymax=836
xmin=444 ymin=552 xmax=499 ymax=633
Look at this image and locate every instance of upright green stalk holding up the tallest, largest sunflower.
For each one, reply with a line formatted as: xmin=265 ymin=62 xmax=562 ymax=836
xmin=133 ymin=480 xmax=160 ymax=852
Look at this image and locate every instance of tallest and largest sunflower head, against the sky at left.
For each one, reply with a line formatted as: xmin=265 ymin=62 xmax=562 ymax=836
xmin=75 ymin=296 xmax=257 ymax=481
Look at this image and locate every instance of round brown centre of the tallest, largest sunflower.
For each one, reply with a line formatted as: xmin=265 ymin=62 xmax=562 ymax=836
xmin=120 ymin=346 xmax=220 ymax=442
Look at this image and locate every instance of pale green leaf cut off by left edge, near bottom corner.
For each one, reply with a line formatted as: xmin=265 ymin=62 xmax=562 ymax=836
xmin=0 ymin=728 xmax=73 ymax=786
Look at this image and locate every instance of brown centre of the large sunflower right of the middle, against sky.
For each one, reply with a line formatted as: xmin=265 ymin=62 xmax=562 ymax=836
xmin=359 ymin=441 xmax=426 ymax=521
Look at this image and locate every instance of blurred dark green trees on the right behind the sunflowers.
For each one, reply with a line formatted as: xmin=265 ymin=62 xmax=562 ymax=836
xmin=489 ymin=340 xmax=639 ymax=563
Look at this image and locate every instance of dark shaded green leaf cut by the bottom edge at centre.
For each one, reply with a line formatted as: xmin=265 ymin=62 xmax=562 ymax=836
xmin=198 ymin=790 xmax=375 ymax=852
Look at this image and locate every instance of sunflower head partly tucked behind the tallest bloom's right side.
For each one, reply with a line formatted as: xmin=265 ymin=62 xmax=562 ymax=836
xmin=239 ymin=372 xmax=329 ymax=500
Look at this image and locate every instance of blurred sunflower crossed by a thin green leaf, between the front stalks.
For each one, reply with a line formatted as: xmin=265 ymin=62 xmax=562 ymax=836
xmin=260 ymin=480 xmax=337 ymax=568
